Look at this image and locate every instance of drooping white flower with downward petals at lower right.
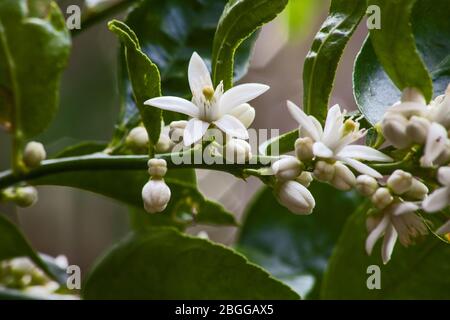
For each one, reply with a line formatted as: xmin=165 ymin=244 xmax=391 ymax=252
xmin=366 ymin=202 xmax=428 ymax=264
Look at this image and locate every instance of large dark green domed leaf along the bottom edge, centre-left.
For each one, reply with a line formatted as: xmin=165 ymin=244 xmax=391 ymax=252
xmin=83 ymin=228 xmax=299 ymax=299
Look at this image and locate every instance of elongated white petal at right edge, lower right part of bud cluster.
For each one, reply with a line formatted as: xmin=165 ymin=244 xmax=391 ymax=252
xmin=420 ymin=122 xmax=447 ymax=167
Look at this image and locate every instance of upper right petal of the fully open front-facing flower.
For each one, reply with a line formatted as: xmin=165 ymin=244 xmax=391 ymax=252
xmin=219 ymin=83 xmax=270 ymax=114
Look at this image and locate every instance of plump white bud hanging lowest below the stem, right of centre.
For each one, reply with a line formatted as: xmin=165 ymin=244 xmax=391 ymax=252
xmin=276 ymin=181 xmax=316 ymax=214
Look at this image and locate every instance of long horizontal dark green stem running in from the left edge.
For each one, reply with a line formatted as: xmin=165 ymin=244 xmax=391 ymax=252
xmin=0 ymin=150 xmax=276 ymax=189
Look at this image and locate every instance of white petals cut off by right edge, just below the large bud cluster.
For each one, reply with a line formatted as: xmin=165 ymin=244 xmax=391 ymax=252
xmin=422 ymin=167 xmax=450 ymax=212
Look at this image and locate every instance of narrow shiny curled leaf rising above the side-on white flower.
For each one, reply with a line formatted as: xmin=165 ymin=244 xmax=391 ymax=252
xmin=303 ymin=0 xmax=367 ymax=122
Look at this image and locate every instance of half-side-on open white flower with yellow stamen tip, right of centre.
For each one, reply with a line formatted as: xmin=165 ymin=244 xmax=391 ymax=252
xmin=287 ymin=101 xmax=392 ymax=178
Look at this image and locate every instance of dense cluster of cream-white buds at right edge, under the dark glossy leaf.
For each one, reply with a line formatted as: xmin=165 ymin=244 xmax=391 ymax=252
xmin=381 ymin=86 xmax=450 ymax=167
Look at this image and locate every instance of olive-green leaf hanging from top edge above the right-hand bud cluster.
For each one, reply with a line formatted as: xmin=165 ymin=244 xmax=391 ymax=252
xmin=368 ymin=0 xmax=434 ymax=101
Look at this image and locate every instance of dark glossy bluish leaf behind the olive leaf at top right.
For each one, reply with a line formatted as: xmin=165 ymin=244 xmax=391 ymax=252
xmin=353 ymin=0 xmax=450 ymax=124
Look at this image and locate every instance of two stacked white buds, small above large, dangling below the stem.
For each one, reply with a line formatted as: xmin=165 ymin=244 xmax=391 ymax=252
xmin=142 ymin=159 xmax=171 ymax=213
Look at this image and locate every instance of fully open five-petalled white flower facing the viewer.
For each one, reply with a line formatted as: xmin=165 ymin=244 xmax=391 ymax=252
xmin=145 ymin=52 xmax=269 ymax=146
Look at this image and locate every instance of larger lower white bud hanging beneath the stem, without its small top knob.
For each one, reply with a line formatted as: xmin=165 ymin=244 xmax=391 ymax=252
xmin=142 ymin=179 xmax=170 ymax=213
